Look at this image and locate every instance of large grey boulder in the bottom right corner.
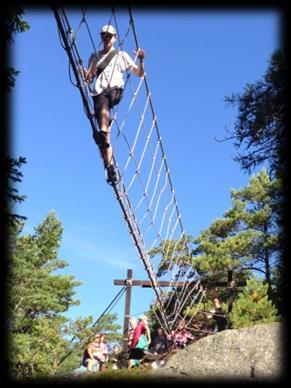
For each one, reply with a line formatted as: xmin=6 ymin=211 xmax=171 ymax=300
xmin=152 ymin=323 xmax=283 ymax=381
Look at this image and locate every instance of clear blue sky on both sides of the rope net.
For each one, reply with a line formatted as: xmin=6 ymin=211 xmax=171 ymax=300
xmin=11 ymin=8 xmax=281 ymax=334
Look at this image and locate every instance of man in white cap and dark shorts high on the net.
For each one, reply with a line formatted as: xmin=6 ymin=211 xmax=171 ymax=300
xmin=84 ymin=25 xmax=145 ymax=184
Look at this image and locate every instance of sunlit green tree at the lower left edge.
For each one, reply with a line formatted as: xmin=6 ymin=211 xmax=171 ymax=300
xmin=7 ymin=212 xmax=81 ymax=378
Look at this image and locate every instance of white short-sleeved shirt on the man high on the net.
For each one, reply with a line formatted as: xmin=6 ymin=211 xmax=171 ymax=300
xmin=88 ymin=48 xmax=137 ymax=96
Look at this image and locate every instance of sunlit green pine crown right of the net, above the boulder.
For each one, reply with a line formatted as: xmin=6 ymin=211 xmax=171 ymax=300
xmin=193 ymin=169 xmax=281 ymax=292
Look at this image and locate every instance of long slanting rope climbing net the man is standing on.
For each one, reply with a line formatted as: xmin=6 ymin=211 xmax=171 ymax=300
xmin=53 ymin=7 xmax=202 ymax=333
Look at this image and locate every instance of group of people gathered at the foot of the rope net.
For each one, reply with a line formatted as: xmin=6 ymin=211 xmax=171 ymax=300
xmin=82 ymin=297 xmax=228 ymax=371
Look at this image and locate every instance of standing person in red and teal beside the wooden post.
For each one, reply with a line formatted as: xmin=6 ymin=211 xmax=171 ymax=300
xmin=128 ymin=315 xmax=151 ymax=369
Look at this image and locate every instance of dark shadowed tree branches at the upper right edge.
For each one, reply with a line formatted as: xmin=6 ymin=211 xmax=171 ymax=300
xmin=226 ymin=51 xmax=287 ymax=180
